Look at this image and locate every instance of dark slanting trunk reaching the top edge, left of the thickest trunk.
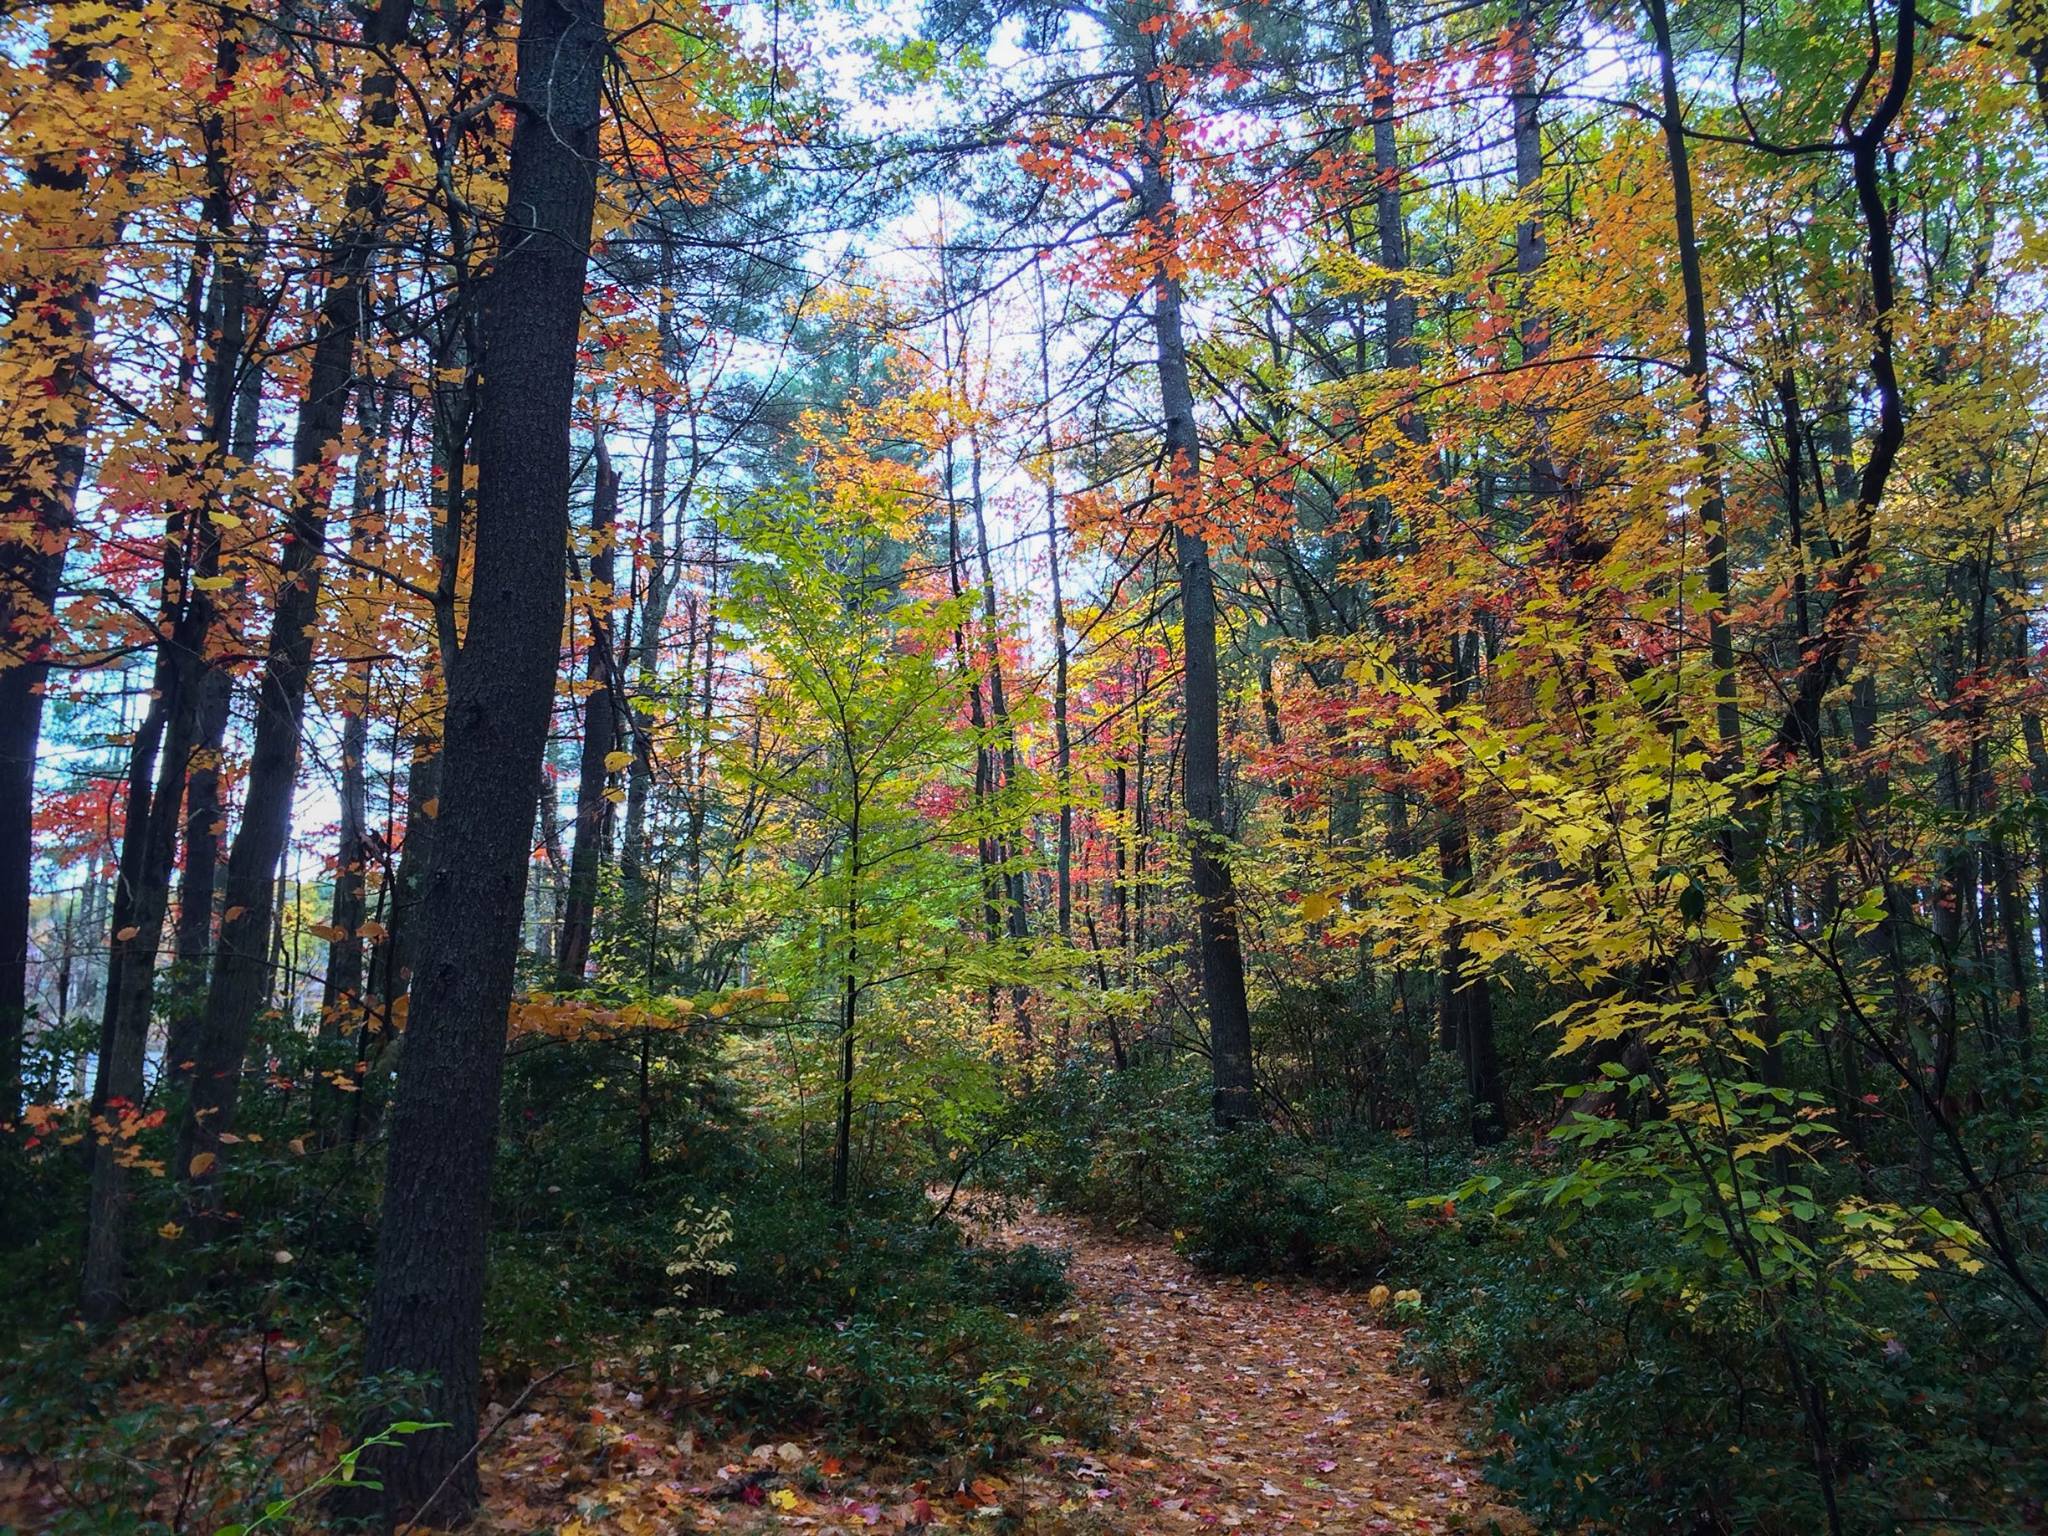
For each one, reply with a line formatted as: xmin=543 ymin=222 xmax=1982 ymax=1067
xmin=172 ymin=0 xmax=412 ymax=1212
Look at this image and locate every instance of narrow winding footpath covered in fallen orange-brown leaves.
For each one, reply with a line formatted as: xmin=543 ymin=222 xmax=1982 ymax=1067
xmin=971 ymin=1214 xmax=1530 ymax=1536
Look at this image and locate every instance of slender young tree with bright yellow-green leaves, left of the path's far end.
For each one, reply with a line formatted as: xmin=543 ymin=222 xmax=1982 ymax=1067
xmin=727 ymin=483 xmax=1016 ymax=1206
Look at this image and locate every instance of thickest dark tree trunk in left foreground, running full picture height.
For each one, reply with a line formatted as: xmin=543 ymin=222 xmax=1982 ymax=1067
xmin=367 ymin=0 xmax=608 ymax=1524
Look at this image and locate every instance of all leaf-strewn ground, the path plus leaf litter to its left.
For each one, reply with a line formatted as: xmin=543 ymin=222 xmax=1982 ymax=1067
xmin=0 ymin=1214 xmax=1530 ymax=1536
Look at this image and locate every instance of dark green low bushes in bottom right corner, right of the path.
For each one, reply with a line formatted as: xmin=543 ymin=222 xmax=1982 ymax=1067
xmin=1403 ymin=1212 xmax=2048 ymax=1536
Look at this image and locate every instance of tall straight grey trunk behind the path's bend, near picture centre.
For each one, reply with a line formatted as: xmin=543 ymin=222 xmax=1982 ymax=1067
xmin=1139 ymin=41 xmax=1257 ymax=1126
